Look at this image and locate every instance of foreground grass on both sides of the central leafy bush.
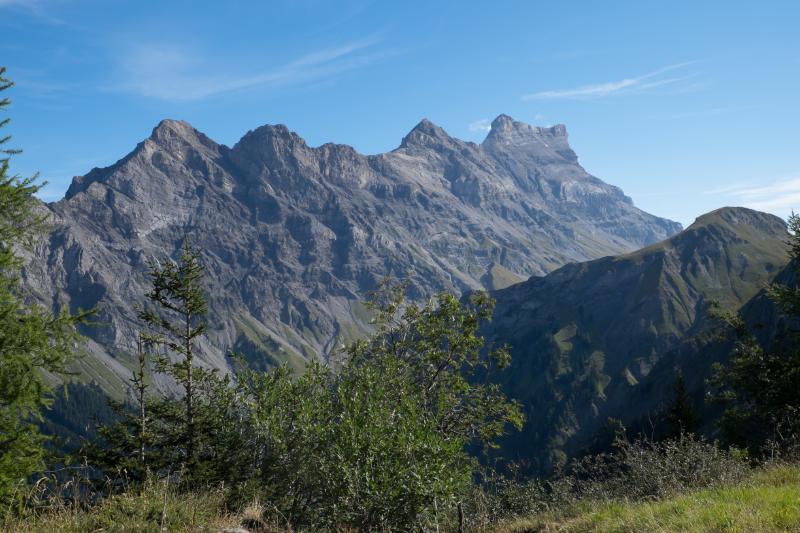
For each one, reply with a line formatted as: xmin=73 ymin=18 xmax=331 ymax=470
xmin=2 ymin=465 xmax=800 ymax=533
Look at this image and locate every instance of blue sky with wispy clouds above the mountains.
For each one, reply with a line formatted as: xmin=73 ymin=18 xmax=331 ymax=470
xmin=0 ymin=0 xmax=800 ymax=224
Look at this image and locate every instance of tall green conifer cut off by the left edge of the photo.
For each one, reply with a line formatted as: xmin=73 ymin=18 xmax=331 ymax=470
xmin=0 ymin=68 xmax=83 ymax=509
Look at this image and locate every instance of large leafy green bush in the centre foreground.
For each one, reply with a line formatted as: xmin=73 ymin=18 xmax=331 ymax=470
xmin=228 ymin=284 xmax=521 ymax=530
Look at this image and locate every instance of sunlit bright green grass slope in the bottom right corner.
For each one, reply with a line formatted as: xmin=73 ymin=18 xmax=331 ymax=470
xmin=498 ymin=465 xmax=800 ymax=533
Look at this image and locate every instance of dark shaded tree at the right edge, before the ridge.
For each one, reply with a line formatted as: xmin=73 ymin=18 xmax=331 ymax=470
xmin=711 ymin=215 xmax=800 ymax=454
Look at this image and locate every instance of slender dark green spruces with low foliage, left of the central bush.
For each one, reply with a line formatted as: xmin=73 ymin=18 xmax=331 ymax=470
xmin=87 ymin=244 xmax=249 ymax=486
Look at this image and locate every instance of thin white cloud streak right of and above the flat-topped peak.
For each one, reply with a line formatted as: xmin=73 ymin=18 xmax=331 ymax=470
xmin=522 ymin=61 xmax=697 ymax=101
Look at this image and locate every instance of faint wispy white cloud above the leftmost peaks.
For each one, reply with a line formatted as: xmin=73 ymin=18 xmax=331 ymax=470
xmin=109 ymin=39 xmax=383 ymax=101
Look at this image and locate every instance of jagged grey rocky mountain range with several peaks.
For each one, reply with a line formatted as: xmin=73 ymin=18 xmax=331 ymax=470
xmin=20 ymin=115 xmax=681 ymax=390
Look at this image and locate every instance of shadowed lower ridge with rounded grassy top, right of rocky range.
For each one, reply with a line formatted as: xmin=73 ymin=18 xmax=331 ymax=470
xmin=489 ymin=208 xmax=788 ymax=470
